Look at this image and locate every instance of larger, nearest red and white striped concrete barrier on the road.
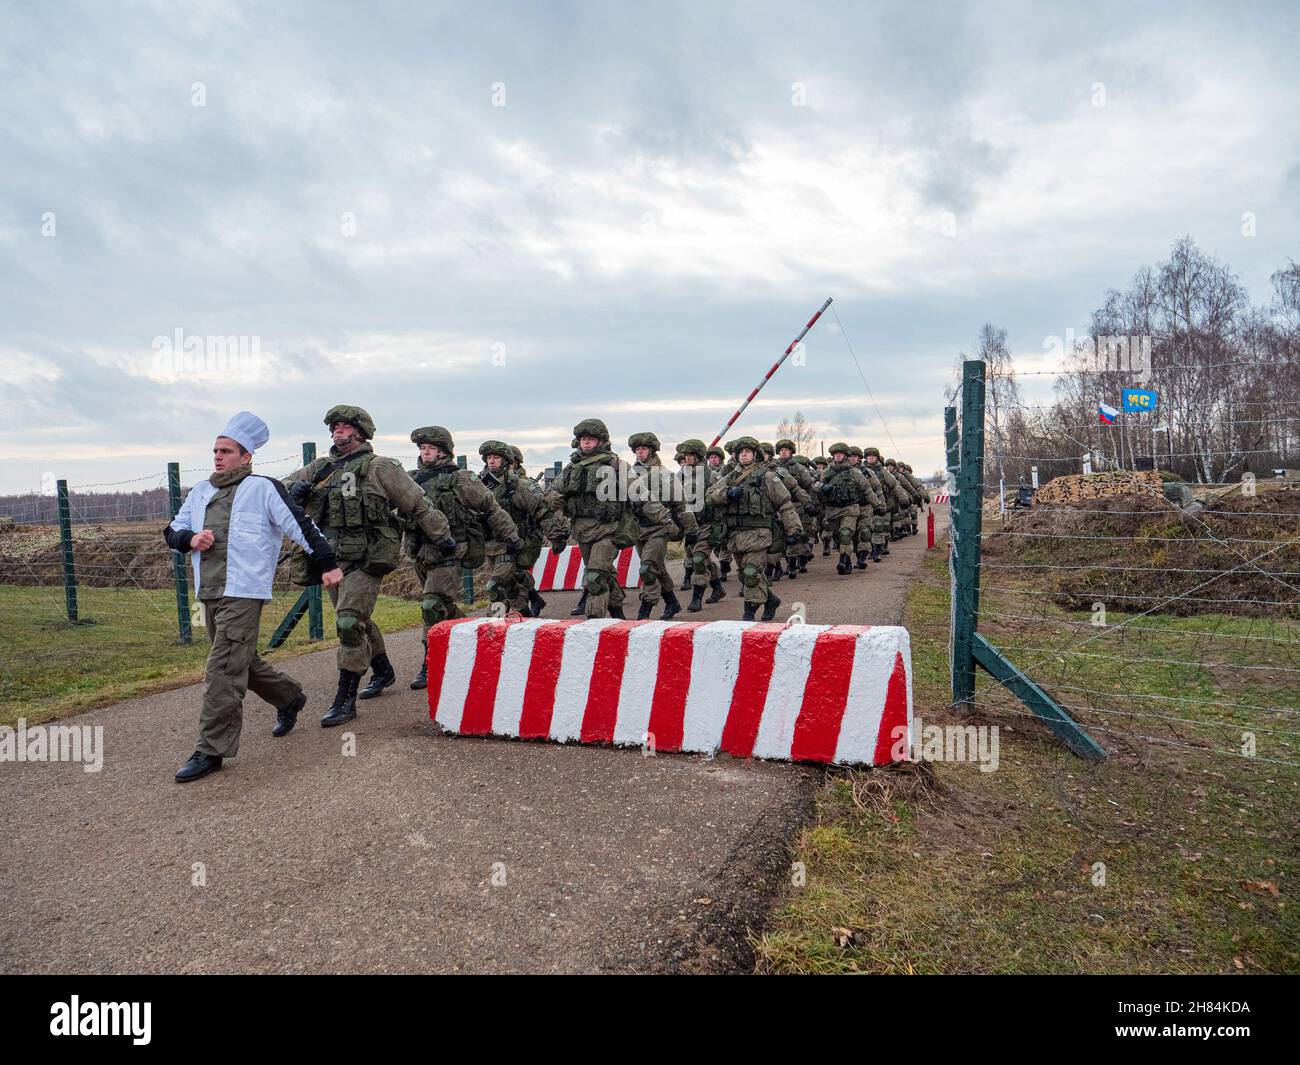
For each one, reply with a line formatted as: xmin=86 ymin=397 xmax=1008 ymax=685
xmin=428 ymin=618 xmax=911 ymax=765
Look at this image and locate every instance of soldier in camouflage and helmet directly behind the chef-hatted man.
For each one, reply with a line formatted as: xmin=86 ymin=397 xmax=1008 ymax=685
xmin=285 ymin=404 xmax=456 ymax=728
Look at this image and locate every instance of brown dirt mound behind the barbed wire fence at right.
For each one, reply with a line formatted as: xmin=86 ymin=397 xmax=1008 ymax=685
xmin=984 ymin=486 xmax=1300 ymax=618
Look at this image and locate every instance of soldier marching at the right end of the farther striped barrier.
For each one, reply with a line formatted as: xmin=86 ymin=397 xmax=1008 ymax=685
xmin=628 ymin=433 xmax=696 ymax=622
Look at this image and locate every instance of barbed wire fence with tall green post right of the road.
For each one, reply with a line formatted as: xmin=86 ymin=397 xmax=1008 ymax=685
xmin=945 ymin=360 xmax=1300 ymax=889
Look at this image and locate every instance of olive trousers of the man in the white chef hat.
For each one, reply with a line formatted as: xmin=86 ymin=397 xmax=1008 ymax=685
xmin=196 ymin=596 xmax=303 ymax=758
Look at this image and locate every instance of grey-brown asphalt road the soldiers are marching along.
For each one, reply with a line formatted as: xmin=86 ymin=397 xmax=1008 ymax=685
xmin=0 ymin=507 xmax=946 ymax=973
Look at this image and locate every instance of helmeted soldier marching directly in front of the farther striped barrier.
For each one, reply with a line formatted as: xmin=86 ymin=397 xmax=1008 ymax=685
xmin=546 ymin=417 xmax=640 ymax=618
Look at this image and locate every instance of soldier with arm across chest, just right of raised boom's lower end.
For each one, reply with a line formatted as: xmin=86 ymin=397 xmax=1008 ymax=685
xmin=705 ymin=437 xmax=803 ymax=622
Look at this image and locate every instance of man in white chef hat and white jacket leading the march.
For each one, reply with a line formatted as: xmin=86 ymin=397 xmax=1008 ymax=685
xmin=163 ymin=411 xmax=343 ymax=784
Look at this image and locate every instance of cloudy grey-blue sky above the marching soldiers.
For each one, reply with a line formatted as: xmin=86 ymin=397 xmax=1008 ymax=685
xmin=0 ymin=0 xmax=1300 ymax=492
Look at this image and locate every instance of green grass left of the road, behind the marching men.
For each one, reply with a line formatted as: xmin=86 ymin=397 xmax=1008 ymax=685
xmin=0 ymin=585 xmax=441 ymax=726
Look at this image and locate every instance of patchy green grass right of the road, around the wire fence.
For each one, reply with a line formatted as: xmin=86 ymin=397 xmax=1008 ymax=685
xmin=754 ymin=546 xmax=1300 ymax=973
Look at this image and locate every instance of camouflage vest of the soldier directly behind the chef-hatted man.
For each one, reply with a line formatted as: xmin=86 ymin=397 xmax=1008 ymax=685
xmin=290 ymin=451 xmax=400 ymax=584
